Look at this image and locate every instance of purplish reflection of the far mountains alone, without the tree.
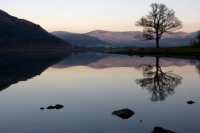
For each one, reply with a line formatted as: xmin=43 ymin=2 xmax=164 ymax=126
xmin=53 ymin=53 xmax=200 ymax=69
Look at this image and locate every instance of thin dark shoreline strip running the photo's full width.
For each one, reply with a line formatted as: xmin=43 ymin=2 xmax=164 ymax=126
xmin=0 ymin=47 xmax=200 ymax=58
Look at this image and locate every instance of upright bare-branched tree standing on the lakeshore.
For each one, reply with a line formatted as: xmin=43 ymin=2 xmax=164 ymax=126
xmin=136 ymin=3 xmax=182 ymax=48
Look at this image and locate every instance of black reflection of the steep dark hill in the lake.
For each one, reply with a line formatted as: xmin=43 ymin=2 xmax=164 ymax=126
xmin=0 ymin=54 xmax=67 ymax=91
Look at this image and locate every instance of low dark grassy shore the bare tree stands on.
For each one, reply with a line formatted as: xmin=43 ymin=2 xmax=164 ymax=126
xmin=73 ymin=46 xmax=200 ymax=58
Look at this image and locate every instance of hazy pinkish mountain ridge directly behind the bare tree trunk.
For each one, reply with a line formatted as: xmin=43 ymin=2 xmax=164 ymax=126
xmin=86 ymin=30 xmax=195 ymax=47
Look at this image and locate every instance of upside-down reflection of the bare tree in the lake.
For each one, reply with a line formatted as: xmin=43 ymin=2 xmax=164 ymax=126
xmin=136 ymin=57 xmax=182 ymax=102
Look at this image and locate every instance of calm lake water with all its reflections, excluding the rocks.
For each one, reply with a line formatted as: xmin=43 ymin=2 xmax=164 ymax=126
xmin=0 ymin=53 xmax=200 ymax=133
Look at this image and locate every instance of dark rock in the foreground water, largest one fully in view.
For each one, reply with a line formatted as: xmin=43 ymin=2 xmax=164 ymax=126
xmin=112 ymin=109 xmax=135 ymax=119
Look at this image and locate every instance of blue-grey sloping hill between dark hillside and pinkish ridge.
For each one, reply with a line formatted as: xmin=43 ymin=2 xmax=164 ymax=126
xmin=52 ymin=31 xmax=110 ymax=47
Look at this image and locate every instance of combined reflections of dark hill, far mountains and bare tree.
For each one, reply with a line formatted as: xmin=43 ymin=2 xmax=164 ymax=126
xmin=0 ymin=53 xmax=200 ymax=101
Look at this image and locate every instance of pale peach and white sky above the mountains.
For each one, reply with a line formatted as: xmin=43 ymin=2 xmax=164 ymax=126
xmin=0 ymin=0 xmax=200 ymax=33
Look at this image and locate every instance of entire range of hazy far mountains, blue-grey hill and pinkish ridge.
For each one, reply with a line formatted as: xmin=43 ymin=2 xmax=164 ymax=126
xmin=53 ymin=30 xmax=196 ymax=48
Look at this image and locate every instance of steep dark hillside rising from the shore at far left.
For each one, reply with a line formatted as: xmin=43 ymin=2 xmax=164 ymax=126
xmin=0 ymin=10 xmax=70 ymax=49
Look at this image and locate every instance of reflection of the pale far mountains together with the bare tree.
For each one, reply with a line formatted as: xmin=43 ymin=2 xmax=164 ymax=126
xmin=53 ymin=53 xmax=200 ymax=102
